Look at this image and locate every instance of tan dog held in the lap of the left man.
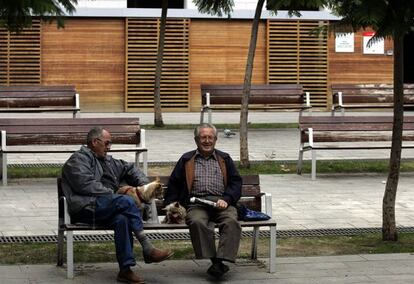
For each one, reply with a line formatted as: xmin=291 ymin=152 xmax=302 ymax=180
xmin=116 ymin=178 xmax=164 ymax=209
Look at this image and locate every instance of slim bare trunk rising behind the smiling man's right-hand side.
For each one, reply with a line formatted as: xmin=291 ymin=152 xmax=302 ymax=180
xmin=240 ymin=0 xmax=265 ymax=168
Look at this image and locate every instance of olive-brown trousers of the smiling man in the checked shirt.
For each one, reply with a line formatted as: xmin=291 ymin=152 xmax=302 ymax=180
xmin=186 ymin=204 xmax=241 ymax=262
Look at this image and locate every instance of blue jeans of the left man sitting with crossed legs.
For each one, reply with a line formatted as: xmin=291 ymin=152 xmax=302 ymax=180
xmin=75 ymin=194 xmax=143 ymax=270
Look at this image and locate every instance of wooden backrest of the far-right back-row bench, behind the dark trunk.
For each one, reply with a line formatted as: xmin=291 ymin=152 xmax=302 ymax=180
xmin=331 ymin=84 xmax=414 ymax=107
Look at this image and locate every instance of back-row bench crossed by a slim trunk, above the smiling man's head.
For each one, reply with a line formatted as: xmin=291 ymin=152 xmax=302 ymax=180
xmin=200 ymin=84 xmax=310 ymax=123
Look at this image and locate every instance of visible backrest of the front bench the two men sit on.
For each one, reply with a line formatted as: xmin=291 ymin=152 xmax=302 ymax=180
xmin=57 ymin=175 xmax=262 ymax=219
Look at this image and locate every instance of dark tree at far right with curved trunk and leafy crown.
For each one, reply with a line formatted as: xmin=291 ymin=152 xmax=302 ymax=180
xmin=329 ymin=0 xmax=414 ymax=241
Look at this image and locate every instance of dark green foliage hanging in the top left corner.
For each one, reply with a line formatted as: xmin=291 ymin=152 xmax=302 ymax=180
xmin=0 ymin=0 xmax=78 ymax=32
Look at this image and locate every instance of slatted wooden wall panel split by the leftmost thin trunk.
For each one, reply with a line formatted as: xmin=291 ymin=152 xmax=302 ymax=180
xmin=125 ymin=18 xmax=190 ymax=111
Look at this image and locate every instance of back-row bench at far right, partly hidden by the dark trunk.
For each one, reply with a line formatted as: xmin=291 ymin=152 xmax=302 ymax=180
xmin=331 ymin=84 xmax=414 ymax=114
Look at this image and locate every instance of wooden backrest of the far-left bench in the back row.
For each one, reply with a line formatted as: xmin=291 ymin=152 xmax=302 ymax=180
xmin=0 ymin=85 xmax=77 ymax=108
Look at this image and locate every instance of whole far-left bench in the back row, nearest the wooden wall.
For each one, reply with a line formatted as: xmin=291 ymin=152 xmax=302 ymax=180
xmin=0 ymin=85 xmax=80 ymax=117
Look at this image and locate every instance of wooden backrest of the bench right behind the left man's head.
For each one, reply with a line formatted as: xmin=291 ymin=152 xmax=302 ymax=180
xmin=0 ymin=117 xmax=140 ymax=146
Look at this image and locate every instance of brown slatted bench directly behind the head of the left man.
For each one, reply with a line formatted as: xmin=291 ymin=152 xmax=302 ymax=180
xmin=0 ymin=117 xmax=147 ymax=185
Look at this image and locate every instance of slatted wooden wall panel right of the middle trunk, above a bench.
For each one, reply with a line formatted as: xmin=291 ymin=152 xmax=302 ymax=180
xmin=267 ymin=20 xmax=328 ymax=108
